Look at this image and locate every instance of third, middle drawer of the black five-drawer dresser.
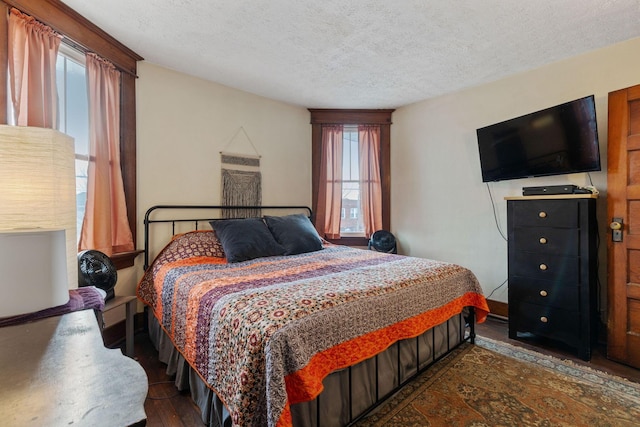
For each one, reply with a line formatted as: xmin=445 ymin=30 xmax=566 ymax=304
xmin=509 ymin=251 xmax=580 ymax=284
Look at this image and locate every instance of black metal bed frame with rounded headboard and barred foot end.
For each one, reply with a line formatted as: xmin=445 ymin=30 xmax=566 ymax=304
xmin=144 ymin=205 xmax=476 ymax=426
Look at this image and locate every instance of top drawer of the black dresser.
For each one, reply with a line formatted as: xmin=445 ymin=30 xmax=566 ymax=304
xmin=510 ymin=200 xmax=578 ymax=228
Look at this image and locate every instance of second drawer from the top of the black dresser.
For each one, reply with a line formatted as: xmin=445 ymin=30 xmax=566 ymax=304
xmin=510 ymin=227 xmax=580 ymax=256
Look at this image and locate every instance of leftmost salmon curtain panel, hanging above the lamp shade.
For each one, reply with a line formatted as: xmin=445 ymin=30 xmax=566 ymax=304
xmin=8 ymin=9 xmax=62 ymax=129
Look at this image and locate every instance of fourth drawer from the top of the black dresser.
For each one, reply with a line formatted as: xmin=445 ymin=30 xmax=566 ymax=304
xmin=509 ymin=276 xmax=580 ymax=311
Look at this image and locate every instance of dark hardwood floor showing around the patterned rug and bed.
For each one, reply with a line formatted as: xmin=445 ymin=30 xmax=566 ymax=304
xmin=130 ymin=317 xmax=640 ymax=427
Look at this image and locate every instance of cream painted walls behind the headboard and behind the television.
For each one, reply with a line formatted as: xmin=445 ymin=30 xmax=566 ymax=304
xmin=110 ymin=39 xmax=640 ymax=324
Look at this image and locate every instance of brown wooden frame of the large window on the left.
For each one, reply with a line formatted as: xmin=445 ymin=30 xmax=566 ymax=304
xmin=0 ymin=0 xmax=144 ymax=269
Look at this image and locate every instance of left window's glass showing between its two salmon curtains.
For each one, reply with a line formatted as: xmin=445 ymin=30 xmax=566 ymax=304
xmin=56 ymin=44 xmax=89 ymax=244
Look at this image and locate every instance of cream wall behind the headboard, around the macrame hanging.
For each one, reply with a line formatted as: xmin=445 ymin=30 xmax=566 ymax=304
xmin=106 ymin=62 xmax=311 ymax=321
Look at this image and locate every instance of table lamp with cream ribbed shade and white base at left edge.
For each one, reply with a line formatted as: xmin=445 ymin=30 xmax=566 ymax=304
xmin=0 ymin=125 xmax=78 ymax=317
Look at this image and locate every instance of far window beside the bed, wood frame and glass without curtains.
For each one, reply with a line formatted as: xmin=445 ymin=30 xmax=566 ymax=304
xmin=309 ymin=109 xmax=394 ymax=246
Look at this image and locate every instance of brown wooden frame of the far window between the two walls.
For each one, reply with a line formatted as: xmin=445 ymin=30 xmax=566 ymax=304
xmin=308 ymin=108 xmax=395 ymax=246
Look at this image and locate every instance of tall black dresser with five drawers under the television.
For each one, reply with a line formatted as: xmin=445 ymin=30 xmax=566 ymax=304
xmin=507 ymin=195 xmax=598 ymax=360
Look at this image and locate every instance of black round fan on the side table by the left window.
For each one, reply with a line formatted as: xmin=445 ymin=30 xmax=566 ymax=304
xmin=78 ymin=249 xmax=118 ymax=300
